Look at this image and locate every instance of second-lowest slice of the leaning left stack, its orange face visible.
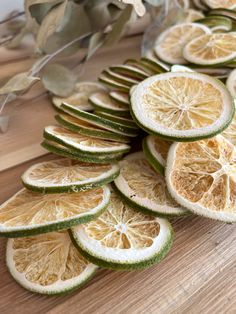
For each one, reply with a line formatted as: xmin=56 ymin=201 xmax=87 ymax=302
xmin=44 ymin=126 xmax=130 ymax=155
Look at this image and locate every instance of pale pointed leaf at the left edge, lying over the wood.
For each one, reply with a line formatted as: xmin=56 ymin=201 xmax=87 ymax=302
xmin=0 ymin=72 xmax=39 ymax=95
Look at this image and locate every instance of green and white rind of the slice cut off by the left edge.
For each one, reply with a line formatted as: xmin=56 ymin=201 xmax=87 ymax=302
xmin=0 ymin=187 xmax=110 ymax=238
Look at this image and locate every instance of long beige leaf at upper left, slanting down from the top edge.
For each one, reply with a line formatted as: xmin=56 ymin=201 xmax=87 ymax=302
xmin=36 ymin=0 xmax=68 ymax=50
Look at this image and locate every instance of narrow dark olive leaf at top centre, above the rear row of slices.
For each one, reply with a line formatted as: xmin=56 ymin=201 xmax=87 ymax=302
xmin=105 ymin=5 xmax=133 ymax=46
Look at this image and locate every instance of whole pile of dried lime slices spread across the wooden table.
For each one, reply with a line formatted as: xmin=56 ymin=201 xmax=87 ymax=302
xmin=0 ymin=0 xmax=236 ymax=294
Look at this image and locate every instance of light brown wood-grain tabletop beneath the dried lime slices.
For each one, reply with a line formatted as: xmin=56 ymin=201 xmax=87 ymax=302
xmin=0 ymin=37 xmax=236 ymax=314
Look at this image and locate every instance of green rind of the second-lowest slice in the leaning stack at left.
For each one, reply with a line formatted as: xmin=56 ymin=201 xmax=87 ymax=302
xmin=43 ymin=126 xmax=130 ymax=156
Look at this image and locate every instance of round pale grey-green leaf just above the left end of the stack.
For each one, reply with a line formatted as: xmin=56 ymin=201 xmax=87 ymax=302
xmin=42 ymin=63 xmax=76 ymax=97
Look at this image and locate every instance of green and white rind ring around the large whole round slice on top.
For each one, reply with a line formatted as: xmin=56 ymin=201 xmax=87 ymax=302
xmin=130 ymin=72 xmax=235 ymax=142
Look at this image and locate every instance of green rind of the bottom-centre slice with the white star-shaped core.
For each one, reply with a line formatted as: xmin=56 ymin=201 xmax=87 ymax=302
xmin=70 ymin=224 xmax=174 ymax=271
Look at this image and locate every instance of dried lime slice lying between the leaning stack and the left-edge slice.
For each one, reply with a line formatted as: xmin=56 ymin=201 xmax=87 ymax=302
xmin=22 ymin=159 xmax=119 ymax=193
